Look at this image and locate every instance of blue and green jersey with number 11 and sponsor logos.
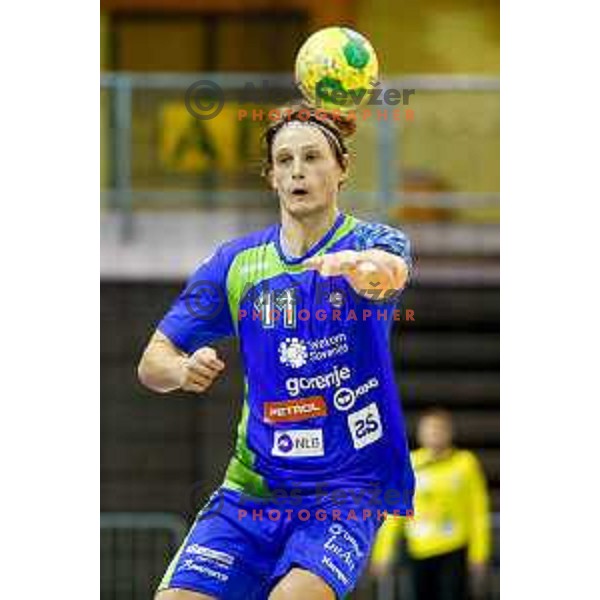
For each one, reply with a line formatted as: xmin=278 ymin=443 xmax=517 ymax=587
xmin=159 ymin=214 xmax=414 ymax=511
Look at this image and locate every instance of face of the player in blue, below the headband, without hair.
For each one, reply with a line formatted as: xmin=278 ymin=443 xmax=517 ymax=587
xmin=270 ymin=125 xmax=345 ymax=217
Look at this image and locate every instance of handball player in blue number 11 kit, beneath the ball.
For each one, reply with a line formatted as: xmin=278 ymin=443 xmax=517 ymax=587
xmin=138 ymin=106 xmax=414 ymax=600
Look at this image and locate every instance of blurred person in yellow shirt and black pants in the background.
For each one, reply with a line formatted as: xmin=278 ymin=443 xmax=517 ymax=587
xmin=371 ymin=408 xmax=490 ymax=600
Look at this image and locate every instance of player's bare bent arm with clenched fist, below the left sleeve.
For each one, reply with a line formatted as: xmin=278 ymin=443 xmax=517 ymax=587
xmin=138 ymin=331 xmax=225 ymax=393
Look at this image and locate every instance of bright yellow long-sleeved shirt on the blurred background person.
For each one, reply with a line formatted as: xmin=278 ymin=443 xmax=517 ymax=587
xmin=372 ymin=448 xmax=490 ymax=563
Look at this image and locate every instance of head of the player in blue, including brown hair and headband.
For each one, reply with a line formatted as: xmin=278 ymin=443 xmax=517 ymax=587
xmin=264 ymin=104 xmax=355 ymax=217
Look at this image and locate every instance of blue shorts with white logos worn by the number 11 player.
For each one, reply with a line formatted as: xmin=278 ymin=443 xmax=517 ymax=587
xmin=159 ymin=488 xmax=383 ymax=600
